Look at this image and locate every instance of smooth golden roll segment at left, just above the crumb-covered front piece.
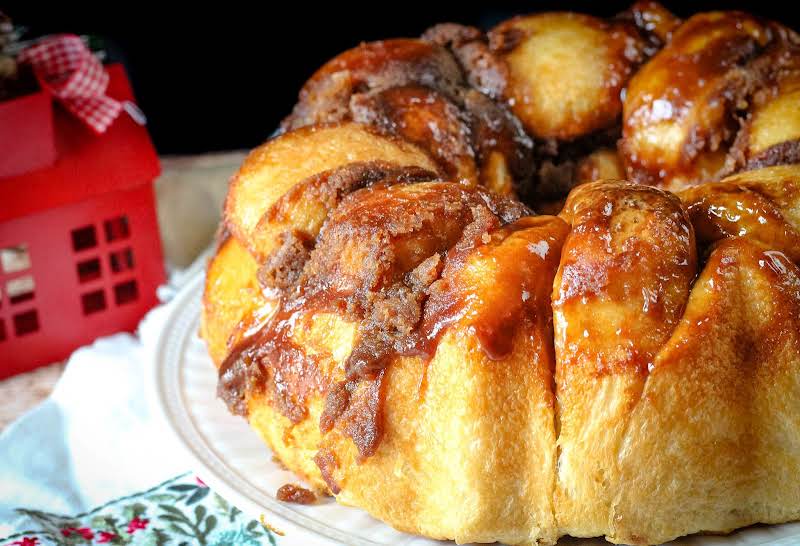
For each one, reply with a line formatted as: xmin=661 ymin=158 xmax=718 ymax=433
xmin=225 ymin=123 xmax=437 ymax=259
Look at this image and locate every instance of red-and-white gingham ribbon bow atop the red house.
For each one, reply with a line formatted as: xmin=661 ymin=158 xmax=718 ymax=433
xmin=19 ymin=34 xmax=144 ymax=134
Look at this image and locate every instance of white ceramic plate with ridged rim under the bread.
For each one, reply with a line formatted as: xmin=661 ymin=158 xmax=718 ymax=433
xmin=150 ymin=274 xmax=800 ymax=546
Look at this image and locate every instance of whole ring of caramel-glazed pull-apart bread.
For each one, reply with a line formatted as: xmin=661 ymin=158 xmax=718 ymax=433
xmin=201 ymin=2 xmax=800 ymax=545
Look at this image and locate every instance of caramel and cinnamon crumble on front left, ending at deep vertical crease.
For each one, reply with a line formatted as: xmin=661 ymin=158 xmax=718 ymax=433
xmin=218 ymin=176 xmax=568 ymax=460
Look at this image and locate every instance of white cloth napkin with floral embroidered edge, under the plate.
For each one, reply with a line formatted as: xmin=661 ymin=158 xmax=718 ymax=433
xmin=0 ymin=260 xmax=289 ymax=546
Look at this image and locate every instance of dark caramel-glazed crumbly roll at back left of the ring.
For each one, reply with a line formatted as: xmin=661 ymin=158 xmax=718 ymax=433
xmin=283 ymin=39 xmax=533 ymax=198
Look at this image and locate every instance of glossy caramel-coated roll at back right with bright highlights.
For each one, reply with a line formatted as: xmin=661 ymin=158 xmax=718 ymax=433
xmin=622 ymin=11 xmax=773 ymax=184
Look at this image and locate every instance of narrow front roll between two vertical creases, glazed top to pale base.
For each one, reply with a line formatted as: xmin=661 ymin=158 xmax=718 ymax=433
xmin=553 ymin=182 xmax=697 ymax=538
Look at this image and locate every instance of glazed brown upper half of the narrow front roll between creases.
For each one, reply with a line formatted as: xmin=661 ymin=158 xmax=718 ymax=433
xmin=553 ymin=182 xmax=697 ymax=376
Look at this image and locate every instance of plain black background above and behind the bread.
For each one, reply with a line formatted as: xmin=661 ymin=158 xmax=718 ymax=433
xmin=0 ymin=0 xmax=800 ymax=154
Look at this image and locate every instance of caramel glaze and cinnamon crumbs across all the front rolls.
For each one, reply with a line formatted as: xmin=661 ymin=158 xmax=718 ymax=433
xmin=219 ymin=174 xmax=798 ymax=468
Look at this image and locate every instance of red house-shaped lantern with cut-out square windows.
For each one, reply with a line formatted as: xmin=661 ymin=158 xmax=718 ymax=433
xmin=0 ymin=65 xmax=164 ymax=379
